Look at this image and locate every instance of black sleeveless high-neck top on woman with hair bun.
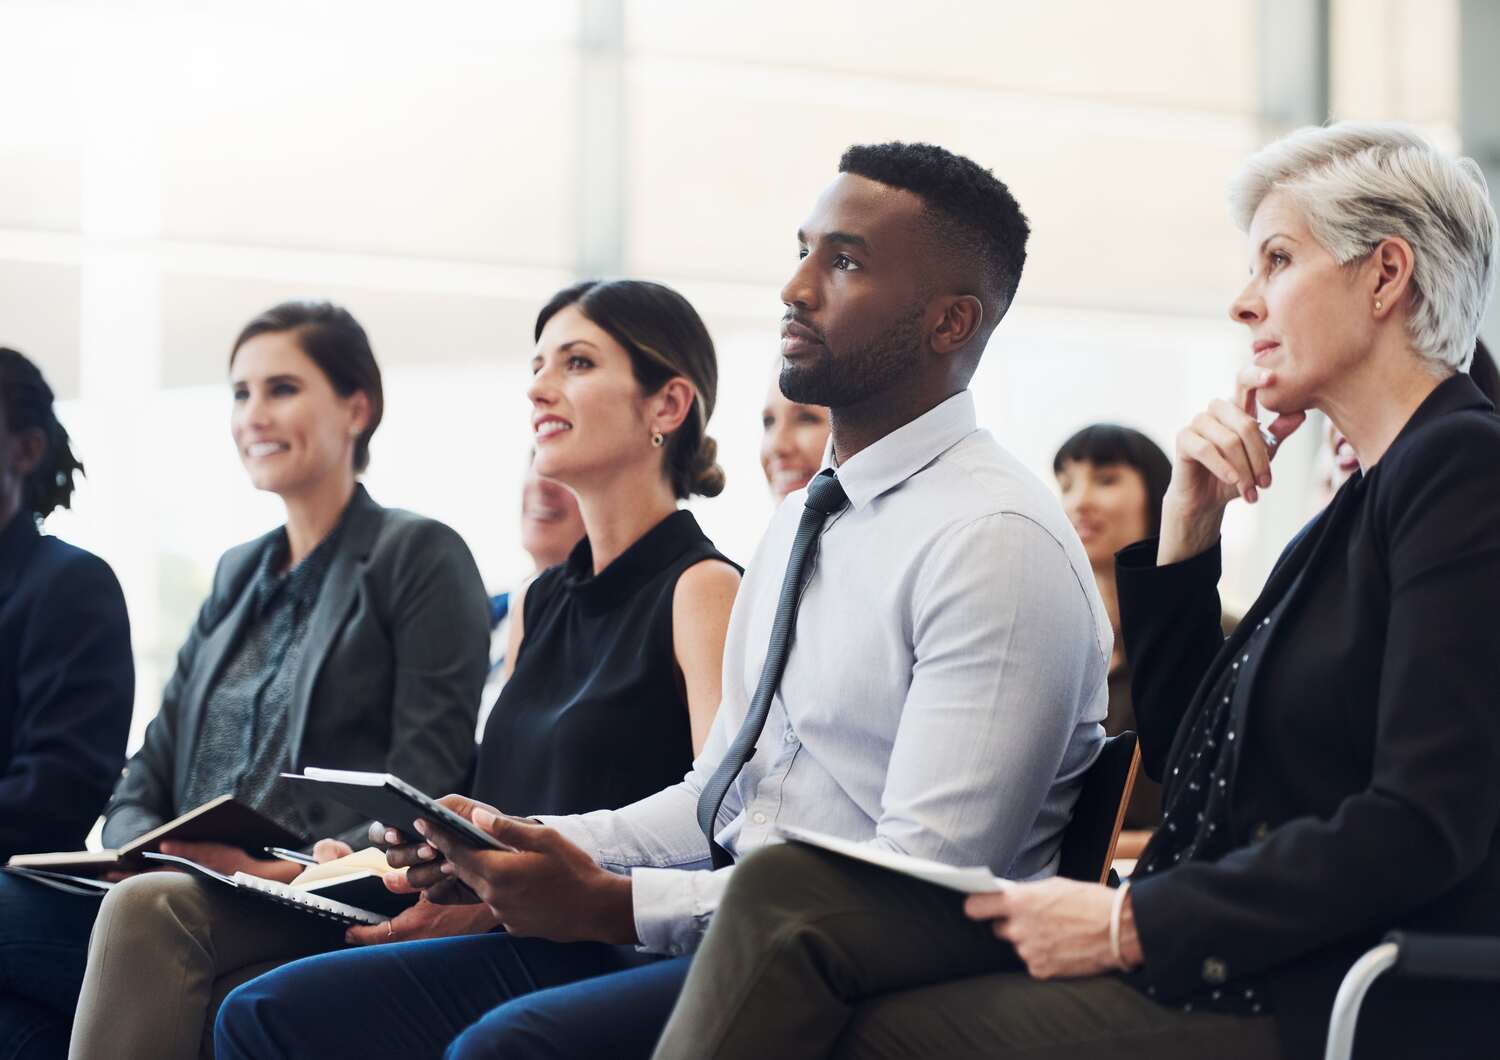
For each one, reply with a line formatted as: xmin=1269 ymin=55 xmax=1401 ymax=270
xmin=474 ymin=510 xmax=729 ymax=817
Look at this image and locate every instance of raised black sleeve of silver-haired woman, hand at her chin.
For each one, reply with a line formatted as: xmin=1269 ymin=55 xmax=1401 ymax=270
xmin=1115 ymin=538 xmax=1224 ymax=783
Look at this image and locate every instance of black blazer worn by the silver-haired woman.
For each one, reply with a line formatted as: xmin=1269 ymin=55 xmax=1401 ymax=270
xmin=1116 ymin=375 xmax=1500 ymax=1057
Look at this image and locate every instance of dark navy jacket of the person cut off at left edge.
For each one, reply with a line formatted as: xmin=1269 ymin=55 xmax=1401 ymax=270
xmin=0 ymin=511 xmax=135 ymax=862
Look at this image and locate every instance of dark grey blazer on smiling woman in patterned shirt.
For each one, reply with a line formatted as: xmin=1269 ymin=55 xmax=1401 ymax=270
xmin=104 ymin=486 xmax=489 ymax=846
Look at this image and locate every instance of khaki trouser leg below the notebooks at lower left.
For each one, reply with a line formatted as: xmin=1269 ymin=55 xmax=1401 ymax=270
xmin=69 ymin=873 xmax=344 ymax=1060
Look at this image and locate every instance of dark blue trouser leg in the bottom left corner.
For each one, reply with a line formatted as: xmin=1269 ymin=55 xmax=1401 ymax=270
xmin=0 ymin=873 xmax=99 ymax=1060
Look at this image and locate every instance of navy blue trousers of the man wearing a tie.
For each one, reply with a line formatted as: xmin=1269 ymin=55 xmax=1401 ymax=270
xmin=213 ymin=933 xmax=690 ymax=1060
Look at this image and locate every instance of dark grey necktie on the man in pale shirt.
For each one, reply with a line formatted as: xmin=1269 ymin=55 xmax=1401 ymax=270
xmin=698 ymin=468 xmax=849 ymax=868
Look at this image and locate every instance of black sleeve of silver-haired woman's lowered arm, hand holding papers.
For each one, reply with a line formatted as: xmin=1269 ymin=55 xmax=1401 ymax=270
xmin=1131 ymin=417 xmax=1500 ymax=997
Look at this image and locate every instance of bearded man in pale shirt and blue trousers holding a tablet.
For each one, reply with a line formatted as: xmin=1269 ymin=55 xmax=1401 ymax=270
xmin=216 ymin=144 xmax=1112 ymax=1057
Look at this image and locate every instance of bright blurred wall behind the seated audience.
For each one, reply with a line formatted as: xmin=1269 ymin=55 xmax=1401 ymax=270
xmin=0 ymin=0 xmax=1500 ymax=738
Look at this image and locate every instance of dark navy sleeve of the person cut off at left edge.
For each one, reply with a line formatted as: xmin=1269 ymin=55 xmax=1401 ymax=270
xmin=0 ymin=553 xmax=135 ymax=856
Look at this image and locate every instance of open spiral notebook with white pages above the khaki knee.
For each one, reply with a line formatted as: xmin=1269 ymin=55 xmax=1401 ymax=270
xmin=144 ymin=849 xmax=417 ymax=925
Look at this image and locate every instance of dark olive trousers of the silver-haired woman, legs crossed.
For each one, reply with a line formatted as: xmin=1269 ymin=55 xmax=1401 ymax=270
xmin=656 ymin=844 xmax=1280 ymax=1060
